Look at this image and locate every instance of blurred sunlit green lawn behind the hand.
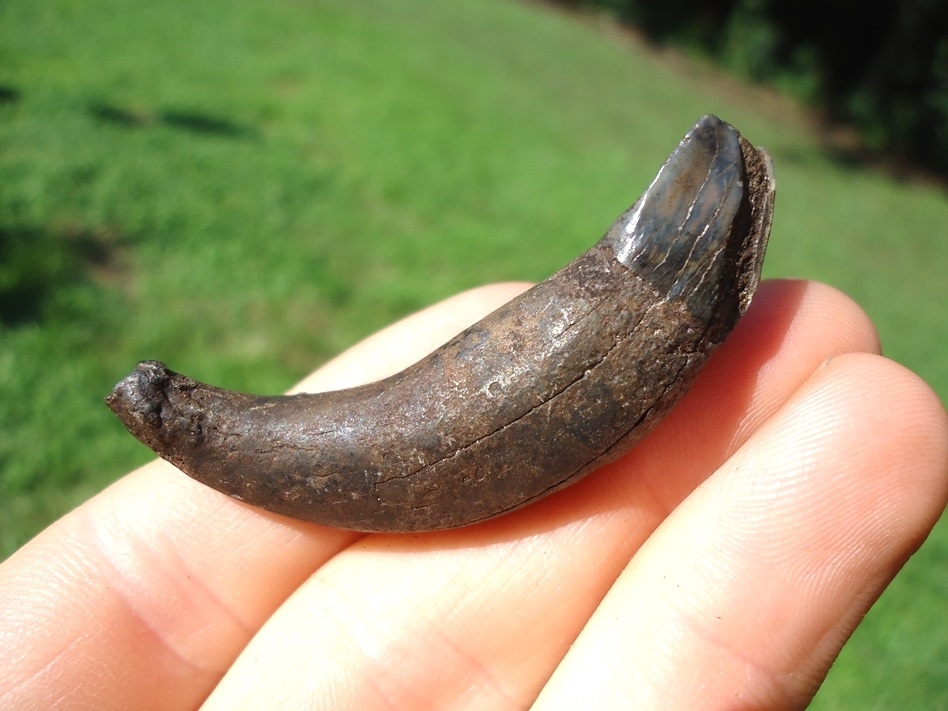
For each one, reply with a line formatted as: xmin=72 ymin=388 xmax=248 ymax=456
xmin=0 ymin=0 xmax=948 ymax=710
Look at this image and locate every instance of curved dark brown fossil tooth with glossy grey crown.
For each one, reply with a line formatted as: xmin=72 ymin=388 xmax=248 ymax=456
xmin=107 ymin=116 xmax=774 ymax=531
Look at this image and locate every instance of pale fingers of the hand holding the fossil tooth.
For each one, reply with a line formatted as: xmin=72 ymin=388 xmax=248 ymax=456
xmin=0 ymin=282 xmax=948 ymax=711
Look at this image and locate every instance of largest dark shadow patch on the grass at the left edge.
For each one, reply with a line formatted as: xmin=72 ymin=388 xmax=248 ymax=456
xmin=0 ymin=225 xmax=126 ymax=327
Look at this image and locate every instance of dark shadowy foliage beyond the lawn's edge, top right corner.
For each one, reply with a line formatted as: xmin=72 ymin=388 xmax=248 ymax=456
xmin=563 ymin=0 xmax=948 ymax=174
